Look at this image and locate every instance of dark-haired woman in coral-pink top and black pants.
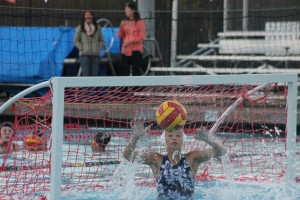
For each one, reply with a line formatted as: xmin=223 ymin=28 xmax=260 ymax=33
xmin=118 ymin=1 xmax=146 ymax=76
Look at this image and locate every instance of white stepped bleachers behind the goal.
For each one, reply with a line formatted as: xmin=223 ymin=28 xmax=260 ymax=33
xmin=150 ymin=22 xmax=300 ymax=74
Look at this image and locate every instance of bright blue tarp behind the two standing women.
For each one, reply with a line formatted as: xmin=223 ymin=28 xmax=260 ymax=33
xmin=0 ymin=26 xmax=120 ymax=84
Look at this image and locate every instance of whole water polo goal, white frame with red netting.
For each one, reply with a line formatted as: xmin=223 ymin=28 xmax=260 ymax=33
xmin=0 ymin=75 xmax=299 ymax=199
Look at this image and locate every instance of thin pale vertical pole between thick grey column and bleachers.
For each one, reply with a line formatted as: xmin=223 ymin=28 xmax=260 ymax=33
xmin=170 ymin=0 xmax=178 ymax=67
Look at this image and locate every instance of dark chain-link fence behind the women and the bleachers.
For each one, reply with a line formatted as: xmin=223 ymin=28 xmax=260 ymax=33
xmin=0 ymin=0 xmax=300 ymax=66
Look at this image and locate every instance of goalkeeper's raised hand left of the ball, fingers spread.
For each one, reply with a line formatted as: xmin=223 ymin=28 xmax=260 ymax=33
xmin=130 ymin=108 xmax=152 ymax=138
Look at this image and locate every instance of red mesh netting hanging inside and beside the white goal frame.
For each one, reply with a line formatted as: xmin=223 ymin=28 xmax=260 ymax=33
xmin=0 ymin=83 xmax=298 ymax=198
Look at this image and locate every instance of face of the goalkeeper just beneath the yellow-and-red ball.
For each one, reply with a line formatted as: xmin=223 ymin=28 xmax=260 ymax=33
xmin=165 ymin=129 xmax=183 ymax=151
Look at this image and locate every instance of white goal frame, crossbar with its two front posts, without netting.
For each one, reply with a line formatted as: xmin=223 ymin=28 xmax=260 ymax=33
xmin=41 ymin=74 xmax=298 ymax=200
